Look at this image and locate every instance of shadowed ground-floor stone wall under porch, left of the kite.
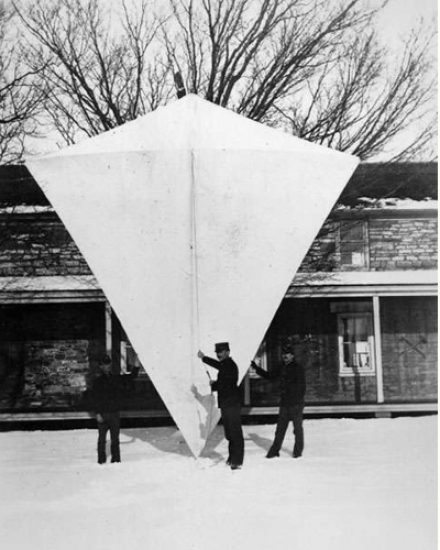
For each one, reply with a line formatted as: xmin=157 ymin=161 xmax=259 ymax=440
xmin=0 ymin=303 xmax=105 ymax=409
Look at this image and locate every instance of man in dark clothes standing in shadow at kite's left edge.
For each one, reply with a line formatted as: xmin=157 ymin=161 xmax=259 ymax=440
xmin=90 ymin=356 xmax=139 ymax=464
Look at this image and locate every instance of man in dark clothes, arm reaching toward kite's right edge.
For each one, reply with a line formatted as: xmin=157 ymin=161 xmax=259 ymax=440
xmin=251 ymin=345 xmax=306 ymax=458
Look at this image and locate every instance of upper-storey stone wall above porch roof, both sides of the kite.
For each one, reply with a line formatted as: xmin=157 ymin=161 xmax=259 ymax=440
xmin=0 ymin=214 xmax=438 ymax=277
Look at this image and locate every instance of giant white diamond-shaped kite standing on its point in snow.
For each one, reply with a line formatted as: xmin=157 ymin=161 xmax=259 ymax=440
xmin=26 ymin=95 xmax=358 ymax=456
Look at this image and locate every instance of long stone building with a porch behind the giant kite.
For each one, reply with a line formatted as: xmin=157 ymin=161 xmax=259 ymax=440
xmin=0 ymin=163 xmax=437 ymax=421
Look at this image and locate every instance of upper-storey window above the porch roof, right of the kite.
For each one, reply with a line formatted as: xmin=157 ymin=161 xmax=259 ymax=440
xmin=339 ymin=220 xmax=367 ymax=267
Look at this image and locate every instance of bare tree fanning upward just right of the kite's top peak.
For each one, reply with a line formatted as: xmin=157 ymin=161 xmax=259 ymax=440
xmin=165 ymin=0 xmax=370 ymax=113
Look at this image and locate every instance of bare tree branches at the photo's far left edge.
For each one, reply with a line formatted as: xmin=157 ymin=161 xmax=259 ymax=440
xmin=0 ymin=4 xmax=44 ymax=164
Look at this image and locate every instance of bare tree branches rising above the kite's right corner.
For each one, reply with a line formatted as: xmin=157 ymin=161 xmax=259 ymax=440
xmin=280 ymin=27 xmax=436 ymax=162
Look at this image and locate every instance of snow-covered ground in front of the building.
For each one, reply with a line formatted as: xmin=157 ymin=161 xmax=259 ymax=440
xmin=0 ymin=416 xmax=437 ymax=550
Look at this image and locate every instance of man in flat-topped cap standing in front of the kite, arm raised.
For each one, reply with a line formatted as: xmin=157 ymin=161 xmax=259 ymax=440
xmin=197 ymin=342 xmax=244 ymax=470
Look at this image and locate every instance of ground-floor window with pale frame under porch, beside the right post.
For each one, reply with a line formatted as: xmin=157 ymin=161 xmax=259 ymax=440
xmin=338 ymin=313 xmax=375 ymax=376
